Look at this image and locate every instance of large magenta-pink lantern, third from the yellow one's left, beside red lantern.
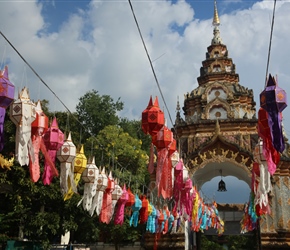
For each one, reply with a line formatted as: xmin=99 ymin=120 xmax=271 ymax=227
xmin=42 ymin=117 xmax=64 ymax=185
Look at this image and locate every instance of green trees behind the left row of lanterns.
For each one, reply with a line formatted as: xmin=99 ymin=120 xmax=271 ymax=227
xmin=0 ymin=90 xmax=150 ymax=248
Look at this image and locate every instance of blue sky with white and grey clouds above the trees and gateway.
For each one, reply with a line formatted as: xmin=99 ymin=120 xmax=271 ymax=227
xmin=0 ymin=0 xmax=290 ymax=202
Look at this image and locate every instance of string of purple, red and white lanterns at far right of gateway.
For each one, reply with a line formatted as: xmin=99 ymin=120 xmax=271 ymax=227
xmin=241 ymin=74 xmax=287 ymax=233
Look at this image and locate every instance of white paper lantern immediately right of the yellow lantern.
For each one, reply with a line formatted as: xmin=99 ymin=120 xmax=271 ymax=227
xmin=78 ymin=157 xmax=99 ymax=211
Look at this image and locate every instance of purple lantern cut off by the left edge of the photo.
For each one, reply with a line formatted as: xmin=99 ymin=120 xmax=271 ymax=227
xmin=0 ymin=66 xmax=14 ymax=151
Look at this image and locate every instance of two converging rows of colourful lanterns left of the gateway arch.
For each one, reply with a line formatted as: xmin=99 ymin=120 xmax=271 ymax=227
xmin=0 ymin=64 xmax=223 ymax=236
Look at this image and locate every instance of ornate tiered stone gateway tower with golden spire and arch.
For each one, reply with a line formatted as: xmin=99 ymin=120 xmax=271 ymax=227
xmin=171 ymin=0 xmax=290 ymax=250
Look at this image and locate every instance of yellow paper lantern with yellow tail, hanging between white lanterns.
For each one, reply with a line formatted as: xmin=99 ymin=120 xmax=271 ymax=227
xmin=64 ymin=145 xmax=87 ymax=200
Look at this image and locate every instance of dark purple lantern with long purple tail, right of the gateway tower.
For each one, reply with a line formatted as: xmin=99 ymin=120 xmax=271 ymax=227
xmin=260 ymin=74 xmax=287 ymax=153
